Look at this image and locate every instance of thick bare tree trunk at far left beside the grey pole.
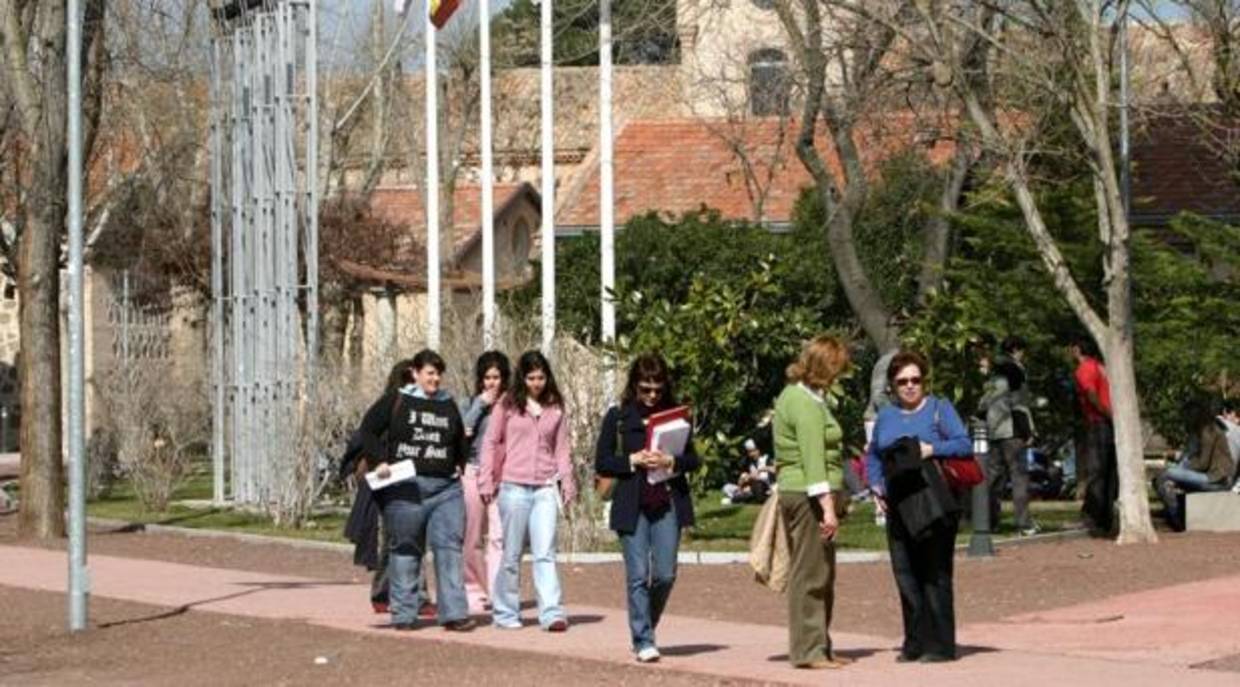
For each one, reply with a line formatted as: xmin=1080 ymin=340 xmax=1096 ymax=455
xmin=0 ymin=0 xmax=105 ymax=538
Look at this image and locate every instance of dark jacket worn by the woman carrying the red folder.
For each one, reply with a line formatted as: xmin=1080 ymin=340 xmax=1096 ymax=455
xmin=594 ymin=406 xmax=702 ymax=534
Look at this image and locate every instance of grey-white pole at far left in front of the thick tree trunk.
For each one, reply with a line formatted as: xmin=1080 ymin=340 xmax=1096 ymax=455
xmin=67 ymin=0 xmax=88 ymax=632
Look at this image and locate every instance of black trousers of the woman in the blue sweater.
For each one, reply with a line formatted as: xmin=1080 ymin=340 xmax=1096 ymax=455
xmin=887 ymin=508 xmax=960 ymax=658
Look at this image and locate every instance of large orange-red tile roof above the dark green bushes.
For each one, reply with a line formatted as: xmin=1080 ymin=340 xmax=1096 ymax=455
xmin=556 ymin=113 xmax=955 ymax=227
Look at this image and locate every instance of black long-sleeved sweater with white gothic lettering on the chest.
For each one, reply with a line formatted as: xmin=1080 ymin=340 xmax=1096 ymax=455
xmin=362 ymin=391 xmax=469 ymax=500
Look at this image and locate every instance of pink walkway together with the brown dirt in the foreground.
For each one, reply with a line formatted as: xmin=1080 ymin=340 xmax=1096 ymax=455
xmin=0 ymin=546 xmax=1240 ymax=687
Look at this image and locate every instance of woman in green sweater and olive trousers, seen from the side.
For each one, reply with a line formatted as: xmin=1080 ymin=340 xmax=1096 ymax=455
xmin=774 ymin=336 xmax=849 ymax=668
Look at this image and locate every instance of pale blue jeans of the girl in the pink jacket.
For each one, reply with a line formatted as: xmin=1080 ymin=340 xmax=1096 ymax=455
xmin=491 ymin=482 xmax=564 ymax=629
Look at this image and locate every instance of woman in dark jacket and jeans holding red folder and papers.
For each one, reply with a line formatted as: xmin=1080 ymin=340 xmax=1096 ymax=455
xmin=594 ymin=353 xmax=699 ymax=663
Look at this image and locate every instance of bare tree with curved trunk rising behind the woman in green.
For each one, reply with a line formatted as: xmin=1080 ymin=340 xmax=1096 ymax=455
xmin=775 ymin=0 xmax=975 ymax=351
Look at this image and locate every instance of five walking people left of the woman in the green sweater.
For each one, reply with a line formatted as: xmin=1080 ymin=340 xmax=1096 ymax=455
xmin=342 ymin=350 xmax=698 ymax=662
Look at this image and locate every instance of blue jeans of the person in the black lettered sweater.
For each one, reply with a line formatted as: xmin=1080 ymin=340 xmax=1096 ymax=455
xmin=383 ymin=477 xmax=469 ymax=625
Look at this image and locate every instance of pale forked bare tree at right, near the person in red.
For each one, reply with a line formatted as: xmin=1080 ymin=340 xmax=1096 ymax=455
xmin=877 ymin=0 xmax=1156 ymax=542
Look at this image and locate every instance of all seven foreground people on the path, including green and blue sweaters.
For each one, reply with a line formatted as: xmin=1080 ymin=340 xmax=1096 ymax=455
xmin=339 ymin=336 xmax=987 ymax=668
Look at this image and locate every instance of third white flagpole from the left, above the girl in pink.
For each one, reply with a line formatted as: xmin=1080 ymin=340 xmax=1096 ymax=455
xmin=539 ymin=0 xmax=556 ymax=355
